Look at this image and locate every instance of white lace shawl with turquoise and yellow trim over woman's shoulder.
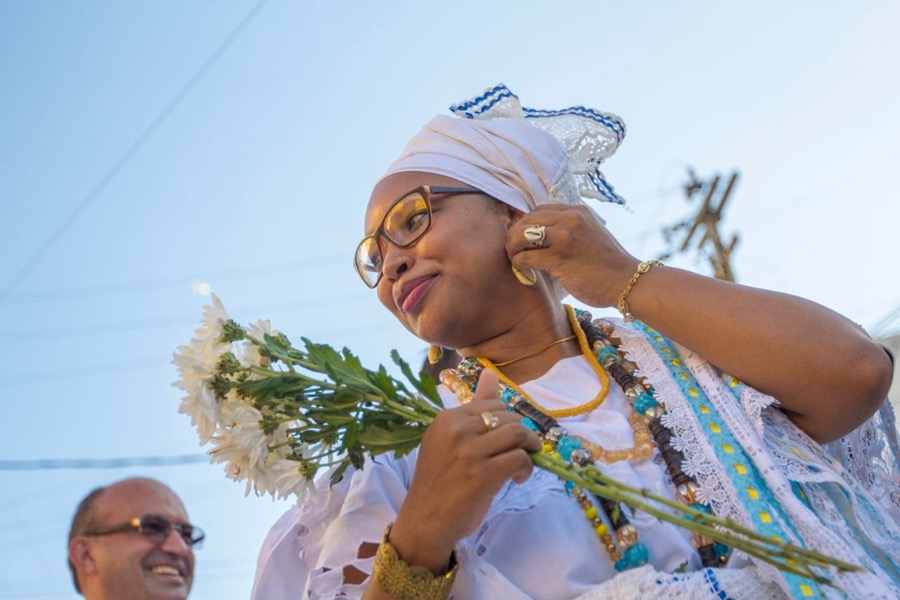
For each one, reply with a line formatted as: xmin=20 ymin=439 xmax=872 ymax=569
xmin=609 ymin=320 xmax=900 ymax=598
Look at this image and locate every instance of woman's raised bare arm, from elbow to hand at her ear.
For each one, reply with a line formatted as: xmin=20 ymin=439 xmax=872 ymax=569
xmin=506 ymin=204 xmax=893 ymax=443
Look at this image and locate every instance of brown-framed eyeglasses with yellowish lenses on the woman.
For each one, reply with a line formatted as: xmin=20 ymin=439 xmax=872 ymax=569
xmin=353 ymin=185 xmax=483 ymax=288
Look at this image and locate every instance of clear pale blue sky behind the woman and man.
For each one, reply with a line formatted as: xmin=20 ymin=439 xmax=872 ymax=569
xmin=0 ymin=0 xmax=900 ymax=599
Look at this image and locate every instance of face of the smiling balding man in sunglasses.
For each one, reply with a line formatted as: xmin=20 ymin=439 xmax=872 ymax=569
xmin=81 ymin=479 xmax=194 ymax=600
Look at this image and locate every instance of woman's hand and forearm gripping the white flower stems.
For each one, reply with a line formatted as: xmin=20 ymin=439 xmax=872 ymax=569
xmin=390 ymin=369 xmax=541 ymax=573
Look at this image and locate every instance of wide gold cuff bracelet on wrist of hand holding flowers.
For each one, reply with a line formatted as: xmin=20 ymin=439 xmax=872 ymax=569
xmin=372 ymin=523 xmax=459 ymax=600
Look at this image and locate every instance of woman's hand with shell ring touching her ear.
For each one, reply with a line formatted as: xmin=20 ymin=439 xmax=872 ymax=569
xmin=506 ymin=204 xmax=639 ymax=307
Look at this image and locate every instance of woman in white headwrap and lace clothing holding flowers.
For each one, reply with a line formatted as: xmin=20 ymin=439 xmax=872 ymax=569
xmin=255 ymin=86 xmax=900 ymax=598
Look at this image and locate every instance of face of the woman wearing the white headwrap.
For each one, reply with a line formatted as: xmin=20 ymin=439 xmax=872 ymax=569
xmin=366 ymin=173 xmax=524 ymax=348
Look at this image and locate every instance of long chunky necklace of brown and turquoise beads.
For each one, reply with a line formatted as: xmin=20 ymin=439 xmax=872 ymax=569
xmin=440 ymin=305 xmax=729 ymax=571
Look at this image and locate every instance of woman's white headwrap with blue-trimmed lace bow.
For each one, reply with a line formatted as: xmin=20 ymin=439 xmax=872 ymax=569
xmin=382 ymin=84 xmax=625 ymax=212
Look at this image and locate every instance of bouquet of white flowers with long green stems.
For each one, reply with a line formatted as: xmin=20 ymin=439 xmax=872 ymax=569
xmin=173 ymin=296 xmax=860 ymax=585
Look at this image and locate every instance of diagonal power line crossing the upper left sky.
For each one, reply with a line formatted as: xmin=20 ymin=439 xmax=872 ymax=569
xmin=0 ymin=0 xmax=268 ymax=302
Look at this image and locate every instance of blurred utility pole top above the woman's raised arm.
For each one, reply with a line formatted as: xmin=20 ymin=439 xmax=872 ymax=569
xmin=659 ymin=168 xmax=738 ymax=281
